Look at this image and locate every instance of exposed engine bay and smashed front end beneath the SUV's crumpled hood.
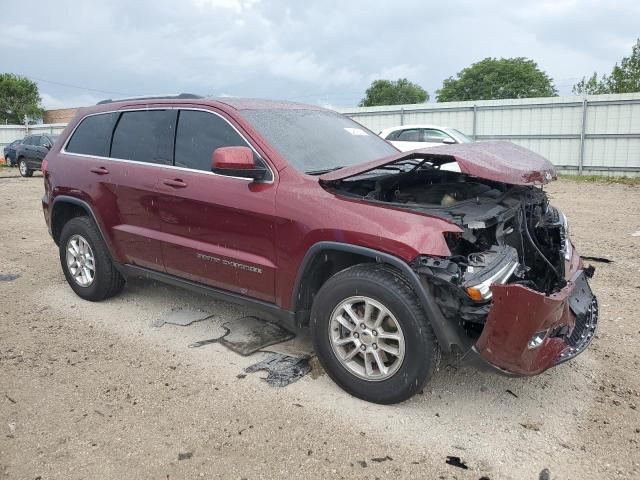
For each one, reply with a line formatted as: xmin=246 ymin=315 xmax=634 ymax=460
xmin=332 ymin=168 xmax=572 ymax=338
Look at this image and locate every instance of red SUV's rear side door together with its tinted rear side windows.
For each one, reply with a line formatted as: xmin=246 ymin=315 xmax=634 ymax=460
xmin=65 ymin=109 xmax=177 ymax=271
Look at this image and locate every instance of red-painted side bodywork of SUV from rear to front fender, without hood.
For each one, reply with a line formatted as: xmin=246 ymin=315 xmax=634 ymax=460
xmin=45 ymin=99 xmax=460 ymax=309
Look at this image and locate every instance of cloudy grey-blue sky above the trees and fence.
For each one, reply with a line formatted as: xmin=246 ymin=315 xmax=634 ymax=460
xmin=0 ymin=0 xmax=640 ymax=109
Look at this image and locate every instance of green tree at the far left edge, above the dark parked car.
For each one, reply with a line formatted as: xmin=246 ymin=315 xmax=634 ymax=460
xmin=0 ymin=73 xmax=44 ymax=124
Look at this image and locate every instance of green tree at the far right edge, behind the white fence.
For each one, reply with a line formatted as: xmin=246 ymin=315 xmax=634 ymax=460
xmin=573 ymin=39 xmax=640 ymax=95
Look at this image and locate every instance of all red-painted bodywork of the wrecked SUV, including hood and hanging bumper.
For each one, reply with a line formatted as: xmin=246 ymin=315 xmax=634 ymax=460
xmin=43 ymin=99 xmax=596 ymax=374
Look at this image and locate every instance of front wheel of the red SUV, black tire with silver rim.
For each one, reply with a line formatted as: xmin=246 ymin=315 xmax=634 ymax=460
xmin=311 ymin=264 xmax=440 ymax=404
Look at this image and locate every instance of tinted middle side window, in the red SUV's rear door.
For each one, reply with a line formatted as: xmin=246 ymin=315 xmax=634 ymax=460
xmin=111 ymin=110 xmax=177 ymax=165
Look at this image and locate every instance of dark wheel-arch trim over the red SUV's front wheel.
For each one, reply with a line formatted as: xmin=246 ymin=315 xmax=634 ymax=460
xmin=291 ymin=241 xmax=471 ymax=352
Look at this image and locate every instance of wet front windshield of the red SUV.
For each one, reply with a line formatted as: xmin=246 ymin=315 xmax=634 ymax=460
xmin=242 ymin=109 xmax=398 ymax=174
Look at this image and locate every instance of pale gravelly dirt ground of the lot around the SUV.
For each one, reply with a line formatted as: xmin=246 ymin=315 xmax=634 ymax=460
xmin=0 ymin=169 xmax=640 ymax=479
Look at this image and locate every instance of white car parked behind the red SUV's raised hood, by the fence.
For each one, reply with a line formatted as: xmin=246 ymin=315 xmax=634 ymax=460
xmin=378 ymin=125 xmax=473 ymax=172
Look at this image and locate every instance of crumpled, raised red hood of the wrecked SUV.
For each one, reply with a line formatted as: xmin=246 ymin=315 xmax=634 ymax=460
xmin=320 ymin=142 xmax=557 ymax=185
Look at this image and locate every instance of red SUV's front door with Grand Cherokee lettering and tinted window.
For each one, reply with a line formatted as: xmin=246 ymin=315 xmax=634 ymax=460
xmin=159 ymin=109 xmax=276 ymax=302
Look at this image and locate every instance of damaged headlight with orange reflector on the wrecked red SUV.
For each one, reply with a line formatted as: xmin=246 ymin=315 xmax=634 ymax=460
xmin=462 ymin=246 xmax=519 ymax=302
